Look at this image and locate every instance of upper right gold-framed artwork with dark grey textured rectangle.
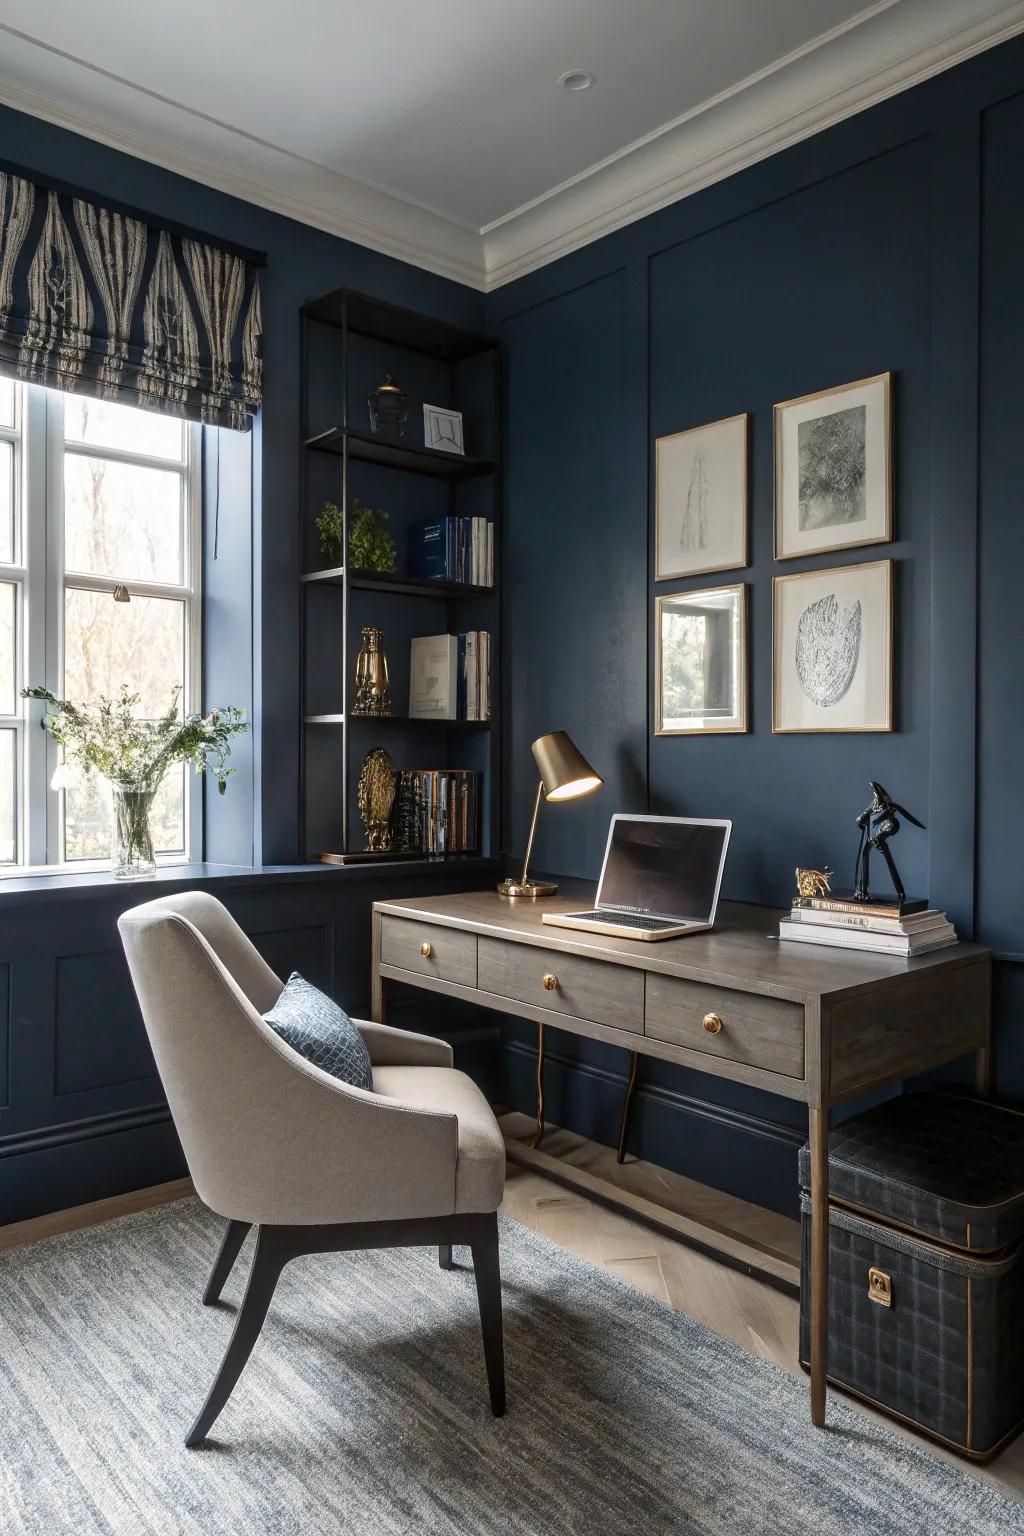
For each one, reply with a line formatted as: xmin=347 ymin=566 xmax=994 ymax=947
xmin=775 ymin=373 xmax=892 ymax=561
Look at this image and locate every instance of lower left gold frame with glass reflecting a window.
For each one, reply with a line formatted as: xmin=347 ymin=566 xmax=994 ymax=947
xmin=654 ymin=582 xmax=748 ymax=736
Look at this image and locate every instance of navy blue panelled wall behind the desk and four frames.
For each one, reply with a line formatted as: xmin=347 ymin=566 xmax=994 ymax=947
xmin=488 ymin=41 xmax=1024 ymax=1209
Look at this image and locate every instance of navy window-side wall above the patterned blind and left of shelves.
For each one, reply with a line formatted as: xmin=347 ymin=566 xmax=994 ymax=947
xmin=0 ymin=106 xmax=484 ymax=863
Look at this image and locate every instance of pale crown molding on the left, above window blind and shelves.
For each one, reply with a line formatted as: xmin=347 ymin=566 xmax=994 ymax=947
xmin=0 ymin=65 xmax=487 ymax=292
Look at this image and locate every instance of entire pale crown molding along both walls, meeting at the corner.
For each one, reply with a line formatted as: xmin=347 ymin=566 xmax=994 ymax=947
xmin=0 ymin=0 xmax=1024 ymax=292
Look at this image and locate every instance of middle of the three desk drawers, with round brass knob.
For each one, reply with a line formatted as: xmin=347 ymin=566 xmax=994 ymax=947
xmin=479 ymin=938 xmax=643 ymax=1034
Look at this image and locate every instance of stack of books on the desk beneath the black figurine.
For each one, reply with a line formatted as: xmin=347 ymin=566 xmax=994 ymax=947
xmin=778 ymin=895 xmax=956 ymax=958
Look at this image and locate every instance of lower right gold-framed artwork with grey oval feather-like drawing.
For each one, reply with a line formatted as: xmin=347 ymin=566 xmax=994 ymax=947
xmin=772 ymin=561 xmax=894 ymax=731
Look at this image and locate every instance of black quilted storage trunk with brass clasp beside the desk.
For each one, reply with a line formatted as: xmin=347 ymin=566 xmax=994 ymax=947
xmin=800 ymin=1094 xmax=1024 ymax=1459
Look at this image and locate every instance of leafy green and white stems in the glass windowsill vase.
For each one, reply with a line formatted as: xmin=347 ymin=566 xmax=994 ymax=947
xmin=23 ymin=684 xmax=249 ymax=794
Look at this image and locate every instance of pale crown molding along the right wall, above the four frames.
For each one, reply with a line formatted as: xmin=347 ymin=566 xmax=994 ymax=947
xmin=482 ymin=0 xmax=1024 ymax=292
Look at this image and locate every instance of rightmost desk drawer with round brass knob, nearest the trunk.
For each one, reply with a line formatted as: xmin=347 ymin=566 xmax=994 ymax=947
xmin=645 ymin=974 xmax=803 ymax=1077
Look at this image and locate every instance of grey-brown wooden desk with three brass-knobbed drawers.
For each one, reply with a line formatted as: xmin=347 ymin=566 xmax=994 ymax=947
xmin=373 ymin=891 xmax=990 ymax=1424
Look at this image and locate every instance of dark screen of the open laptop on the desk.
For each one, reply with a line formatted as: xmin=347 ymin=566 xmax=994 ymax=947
xmin=597 ymin=816 xmax=731 ymax=923
